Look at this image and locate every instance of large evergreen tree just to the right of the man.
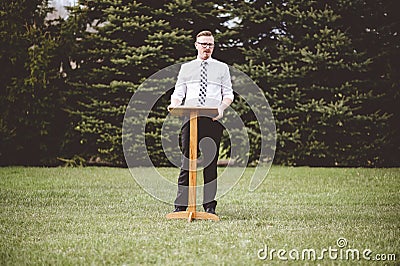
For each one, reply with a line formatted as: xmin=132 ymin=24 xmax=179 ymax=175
xmin=233 ymin=1 xmax=388 ymax=166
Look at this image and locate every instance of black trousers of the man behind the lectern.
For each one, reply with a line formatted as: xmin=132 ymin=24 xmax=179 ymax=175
xmin=175 ymin=117 xmax=223 ymax=209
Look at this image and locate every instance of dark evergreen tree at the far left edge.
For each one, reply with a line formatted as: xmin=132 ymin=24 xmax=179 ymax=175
xmin=0 ymin=0 xmax=65 ymax=164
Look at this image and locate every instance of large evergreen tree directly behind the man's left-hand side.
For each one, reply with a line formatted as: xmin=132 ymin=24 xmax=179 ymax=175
xmin=68 ymin=1 xmax=233 ymax=164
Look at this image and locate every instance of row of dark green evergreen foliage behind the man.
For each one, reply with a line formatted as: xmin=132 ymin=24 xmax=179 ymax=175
xmin=0 ymin=0 xmax=400 ymax=166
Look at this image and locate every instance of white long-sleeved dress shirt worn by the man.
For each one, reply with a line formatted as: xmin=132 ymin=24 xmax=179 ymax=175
xmin=171 ymin=57 xmax=233 ymax=107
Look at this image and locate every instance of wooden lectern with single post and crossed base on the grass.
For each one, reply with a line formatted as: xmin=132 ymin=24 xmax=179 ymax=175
xmin=166 ymin=106 xmax=219 ymax=222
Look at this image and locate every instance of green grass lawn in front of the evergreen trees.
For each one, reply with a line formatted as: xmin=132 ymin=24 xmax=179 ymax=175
xmin=0 ymin=167 xmax=400 ymax=265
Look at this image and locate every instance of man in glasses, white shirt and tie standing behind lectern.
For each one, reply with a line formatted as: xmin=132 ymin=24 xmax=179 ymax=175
xmin=168 ymin=31 xmax=233 ymax=214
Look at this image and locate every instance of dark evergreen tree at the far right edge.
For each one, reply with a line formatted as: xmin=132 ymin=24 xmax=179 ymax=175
xmin=332 ymin=0 xmax=400 ymax=166
